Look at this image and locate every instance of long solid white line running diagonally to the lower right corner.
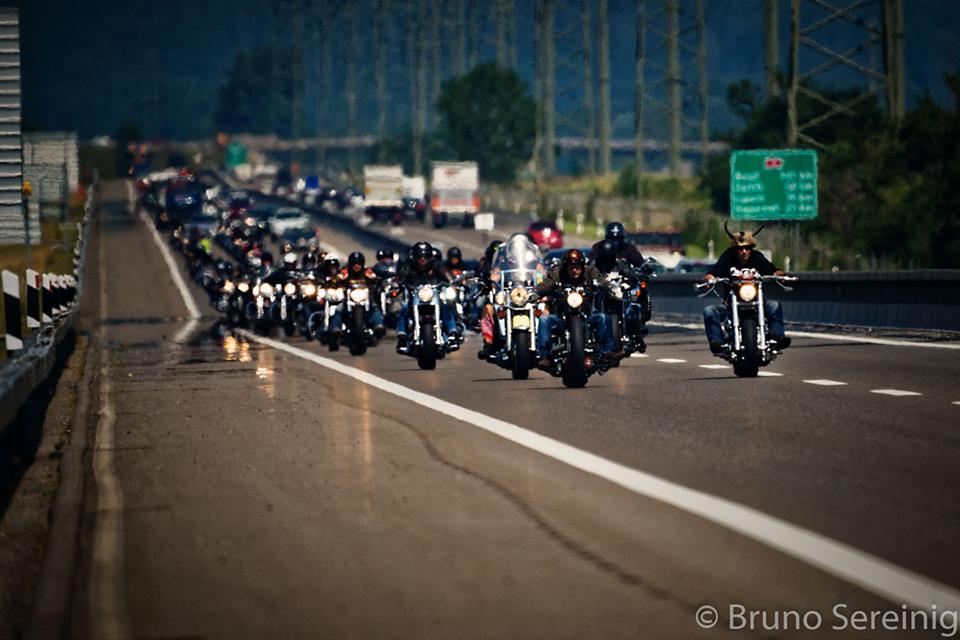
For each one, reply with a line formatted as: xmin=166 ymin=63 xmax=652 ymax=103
xmin=238 ymin=330 xmax=960 ymax=609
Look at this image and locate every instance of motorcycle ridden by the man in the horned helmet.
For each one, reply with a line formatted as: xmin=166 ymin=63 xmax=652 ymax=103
xmin=695 ymin=268 xmax=797 ymax=378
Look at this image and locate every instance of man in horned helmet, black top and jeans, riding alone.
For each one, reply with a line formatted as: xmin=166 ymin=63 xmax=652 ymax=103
xmin=703 ymin=226 xmax=791 ymax=354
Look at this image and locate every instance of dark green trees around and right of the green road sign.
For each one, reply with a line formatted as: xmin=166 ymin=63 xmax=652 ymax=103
xmin=689 ymin=73 xmax=960 ymax=269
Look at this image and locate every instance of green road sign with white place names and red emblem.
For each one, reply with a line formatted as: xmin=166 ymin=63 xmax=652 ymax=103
xmin=730 ymin=149 xmax=817 ymax=220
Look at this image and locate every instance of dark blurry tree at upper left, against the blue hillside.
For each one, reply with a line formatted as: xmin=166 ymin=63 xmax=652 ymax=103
xmin=214 ymin=45 xmax=303 ymax=138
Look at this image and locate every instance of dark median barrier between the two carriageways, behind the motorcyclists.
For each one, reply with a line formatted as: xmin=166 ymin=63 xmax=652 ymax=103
xmin=210 ymin=172 xmax=960 ymax=331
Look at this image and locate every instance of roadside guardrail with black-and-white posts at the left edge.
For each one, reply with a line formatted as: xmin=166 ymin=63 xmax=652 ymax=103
xmin=0 ymin=181 xmax=96 ymax=442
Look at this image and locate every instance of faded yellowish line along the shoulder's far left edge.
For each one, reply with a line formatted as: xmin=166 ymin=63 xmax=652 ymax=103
xmin=89 ymin=212 xmax=130 ymax=638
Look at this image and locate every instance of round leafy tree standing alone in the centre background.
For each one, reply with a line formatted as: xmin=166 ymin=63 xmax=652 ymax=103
xmin=436 ymin=62 xmax=536 ymax=182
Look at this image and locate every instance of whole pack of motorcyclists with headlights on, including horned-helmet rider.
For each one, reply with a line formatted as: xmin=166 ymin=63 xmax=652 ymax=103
xmin=152 ymin=182 xmax=795 ymax=387
